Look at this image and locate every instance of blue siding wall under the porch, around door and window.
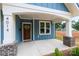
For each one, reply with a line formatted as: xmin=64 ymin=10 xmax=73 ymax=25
xmin=16 ymin=17 xmax=55 ymax=42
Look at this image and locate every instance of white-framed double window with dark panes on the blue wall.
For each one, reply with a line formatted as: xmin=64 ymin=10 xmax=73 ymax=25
xmin=39 ymin=21 xmax=51 ymax=35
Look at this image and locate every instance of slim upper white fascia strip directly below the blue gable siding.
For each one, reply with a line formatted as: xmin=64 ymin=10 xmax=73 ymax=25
xmin=2 ymin=3 xmax=71 ymax=16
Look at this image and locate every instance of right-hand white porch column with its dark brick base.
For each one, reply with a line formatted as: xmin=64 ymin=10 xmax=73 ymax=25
xmin=63 ymin=19 xmax=75 ymax=47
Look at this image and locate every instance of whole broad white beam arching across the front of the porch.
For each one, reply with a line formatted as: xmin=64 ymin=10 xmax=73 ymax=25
xmin=2 ymin=3 xmax=70 ymax=20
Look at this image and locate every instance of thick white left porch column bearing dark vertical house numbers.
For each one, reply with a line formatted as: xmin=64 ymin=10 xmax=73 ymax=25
xmin=3 ymin=15 xmax=15 ymax=44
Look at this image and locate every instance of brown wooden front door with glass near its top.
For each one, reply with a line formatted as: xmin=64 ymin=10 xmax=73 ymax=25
xmin=23 ymin=24 xmax=31 ymax=41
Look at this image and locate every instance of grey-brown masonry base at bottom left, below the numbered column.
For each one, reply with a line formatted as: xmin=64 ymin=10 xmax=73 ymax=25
xmin=0 ymin=43 xmax=17 ymax=56
